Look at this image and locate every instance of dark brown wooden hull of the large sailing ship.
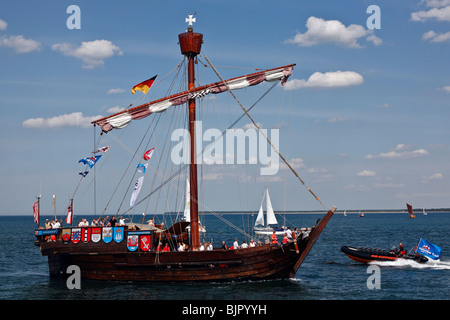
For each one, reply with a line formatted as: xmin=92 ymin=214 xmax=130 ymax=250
xmin=36 ymin=207 xmax=335 ymax=282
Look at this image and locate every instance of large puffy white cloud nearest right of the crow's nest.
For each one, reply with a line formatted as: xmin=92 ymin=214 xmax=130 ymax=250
xmin=286 ymin=17 xmax=382 ymax=48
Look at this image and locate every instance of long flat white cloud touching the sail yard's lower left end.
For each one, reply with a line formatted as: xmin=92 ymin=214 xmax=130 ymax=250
xmin=22 ymin=112 xmax=102 ymax=129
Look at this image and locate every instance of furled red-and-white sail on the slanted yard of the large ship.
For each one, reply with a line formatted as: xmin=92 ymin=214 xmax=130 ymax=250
xmin=92 ymin=64 xmax=295 ymax=132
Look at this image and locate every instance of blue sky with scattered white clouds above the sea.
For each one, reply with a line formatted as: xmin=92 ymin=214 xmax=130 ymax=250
xmin=0 ymin=0 xmax=450 ymax=215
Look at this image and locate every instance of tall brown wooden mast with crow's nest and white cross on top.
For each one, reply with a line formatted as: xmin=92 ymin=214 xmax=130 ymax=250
xmin=178 ymin=15 xmax=203 ymax=250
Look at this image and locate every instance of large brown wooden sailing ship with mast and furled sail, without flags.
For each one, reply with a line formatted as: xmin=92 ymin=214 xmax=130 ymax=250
xmin=35 ymin=17 xmax=335 ymax=281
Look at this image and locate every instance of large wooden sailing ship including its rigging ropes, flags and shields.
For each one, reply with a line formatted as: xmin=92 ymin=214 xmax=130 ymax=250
xmin=35 ymin=17 xmax=336 ymax=282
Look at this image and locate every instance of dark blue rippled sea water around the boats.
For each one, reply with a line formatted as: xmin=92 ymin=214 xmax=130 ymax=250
xmin=0 ymin=212 xmax=450 ymax=301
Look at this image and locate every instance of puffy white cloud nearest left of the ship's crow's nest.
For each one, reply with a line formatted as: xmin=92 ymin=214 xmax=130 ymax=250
xmin=52 ymin=40 xmax=123 ymax=69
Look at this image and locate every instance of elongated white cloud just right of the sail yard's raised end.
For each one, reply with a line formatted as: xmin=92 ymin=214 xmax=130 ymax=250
xmin=284 ymin=70 xmax=364 ymax=90
